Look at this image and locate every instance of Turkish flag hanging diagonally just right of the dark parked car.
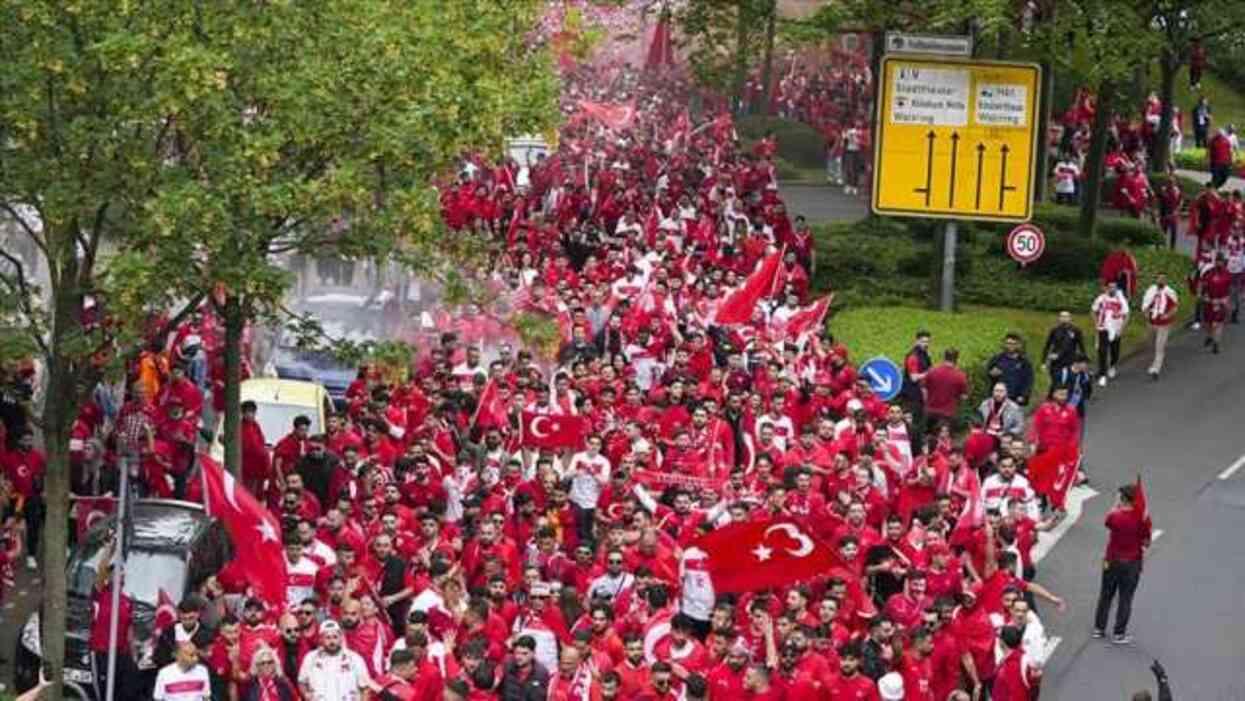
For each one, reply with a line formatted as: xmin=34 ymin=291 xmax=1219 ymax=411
xmin=199 ymin=454 xmax=286 ymax=610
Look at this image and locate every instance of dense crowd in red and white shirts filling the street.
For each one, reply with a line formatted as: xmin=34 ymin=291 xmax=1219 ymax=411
xmin=0 ymin=38 xmax=1180 ymax=701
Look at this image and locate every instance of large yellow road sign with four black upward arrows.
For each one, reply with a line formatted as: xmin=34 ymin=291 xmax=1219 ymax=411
xmin=873 ymin=56 xmax=1041 ymax=222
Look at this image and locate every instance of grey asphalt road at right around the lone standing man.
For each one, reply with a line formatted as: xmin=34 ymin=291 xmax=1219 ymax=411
xmin=1038 ymin=318 xmax=1245 ymax=701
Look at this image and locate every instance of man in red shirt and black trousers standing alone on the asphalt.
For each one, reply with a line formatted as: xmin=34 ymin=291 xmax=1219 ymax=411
xmin=1093 ymin=484 xmax=1150 ymax=645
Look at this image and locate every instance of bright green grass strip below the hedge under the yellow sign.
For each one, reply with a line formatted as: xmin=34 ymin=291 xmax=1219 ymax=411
xmin=829 ymin=305 xmax=1191 ymax=407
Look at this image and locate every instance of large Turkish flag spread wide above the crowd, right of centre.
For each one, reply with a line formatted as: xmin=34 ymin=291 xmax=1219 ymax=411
xmin=691 ymin=518 xmax=837 ymax=594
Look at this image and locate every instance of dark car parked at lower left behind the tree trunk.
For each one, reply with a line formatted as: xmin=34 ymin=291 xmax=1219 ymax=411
xmin=14 ymin=499 xmax=233 ymax=701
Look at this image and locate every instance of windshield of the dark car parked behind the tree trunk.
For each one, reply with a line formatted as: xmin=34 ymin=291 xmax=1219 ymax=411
xmin=68 ymin=533 xmax=186 ymax=606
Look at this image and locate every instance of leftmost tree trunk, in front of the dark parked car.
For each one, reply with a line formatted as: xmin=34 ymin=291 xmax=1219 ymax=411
xmin=40 ymin=233 xmax=82 ymax=701
